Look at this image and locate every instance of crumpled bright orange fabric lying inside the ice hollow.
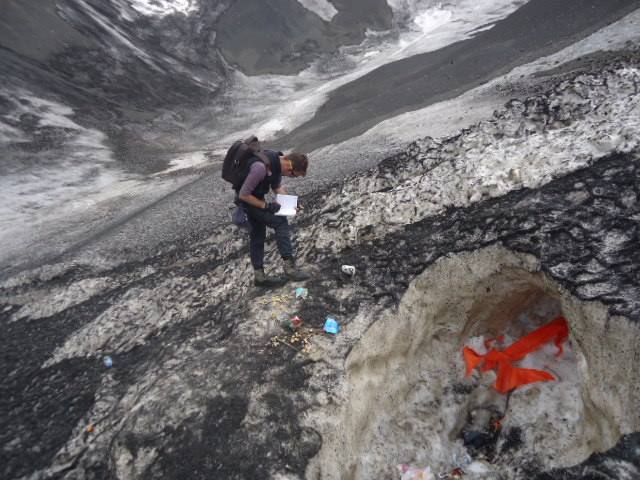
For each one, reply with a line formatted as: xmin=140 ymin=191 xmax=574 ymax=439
xmin=462 ymin=317 xmax=569 ymax=393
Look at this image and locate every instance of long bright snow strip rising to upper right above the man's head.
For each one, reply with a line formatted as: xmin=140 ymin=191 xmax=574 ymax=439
xmin=204 ymin=0 xmax=526 ymax=148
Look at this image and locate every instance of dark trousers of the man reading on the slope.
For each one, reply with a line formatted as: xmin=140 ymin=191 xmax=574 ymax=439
xmin=244 ymin=204 xmax=293 ymax=268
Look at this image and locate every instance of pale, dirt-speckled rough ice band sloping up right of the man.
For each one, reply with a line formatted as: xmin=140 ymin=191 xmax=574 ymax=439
xmin=309 ymin=64 xmax=640 ymax=253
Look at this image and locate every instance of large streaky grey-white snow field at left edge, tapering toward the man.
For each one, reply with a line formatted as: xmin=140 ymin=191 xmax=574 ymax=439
xmin=0 ymin=88 xmax=203 ymax=276
